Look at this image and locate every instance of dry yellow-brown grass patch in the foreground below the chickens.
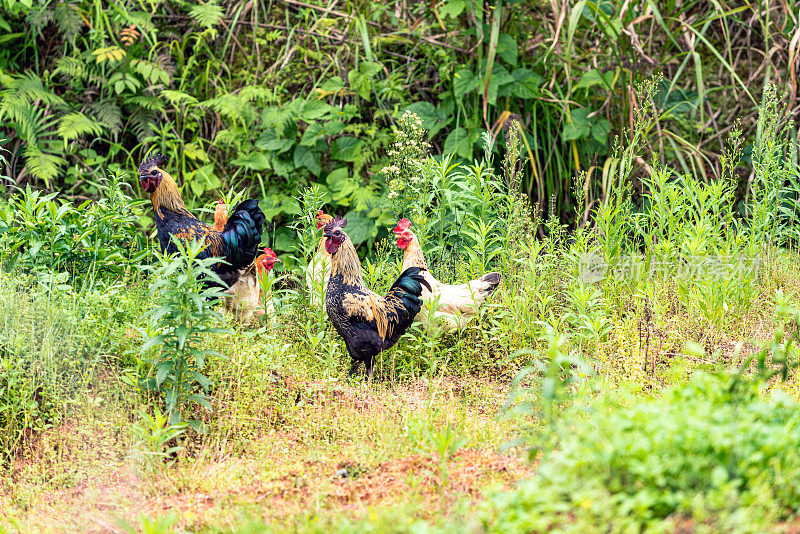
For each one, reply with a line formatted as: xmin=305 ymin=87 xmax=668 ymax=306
xmin=0 ymin=370 xmax=532 ymax=532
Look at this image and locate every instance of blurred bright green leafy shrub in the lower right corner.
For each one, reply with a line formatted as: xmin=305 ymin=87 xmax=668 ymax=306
xmin=472 ymin=374 xmax=800 ymax=532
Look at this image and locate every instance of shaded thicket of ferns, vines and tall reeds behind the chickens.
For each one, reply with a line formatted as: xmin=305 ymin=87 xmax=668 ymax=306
xmin=0 ymin=0 xmax=797 ymax=252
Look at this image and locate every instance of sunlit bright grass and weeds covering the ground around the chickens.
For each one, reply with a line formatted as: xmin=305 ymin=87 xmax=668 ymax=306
xmin=0 ymin=82 xmax=800 ymax=532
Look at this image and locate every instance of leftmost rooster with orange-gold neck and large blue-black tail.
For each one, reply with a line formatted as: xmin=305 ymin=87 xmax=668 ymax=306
xmin=139 ymin=154 xmax=264 ymax=287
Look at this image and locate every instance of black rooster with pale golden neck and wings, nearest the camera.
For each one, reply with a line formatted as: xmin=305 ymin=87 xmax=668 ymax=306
xmin=323 ymin=218 xmax=430 ymax=378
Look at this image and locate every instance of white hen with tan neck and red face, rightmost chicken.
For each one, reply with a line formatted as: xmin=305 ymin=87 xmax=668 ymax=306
xmin=394 ymin=219 xmax=503 ymax=332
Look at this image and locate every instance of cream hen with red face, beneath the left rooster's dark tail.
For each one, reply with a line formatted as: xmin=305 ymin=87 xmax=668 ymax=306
xmin=221 ymin=248 xmax=281 ymax=323
